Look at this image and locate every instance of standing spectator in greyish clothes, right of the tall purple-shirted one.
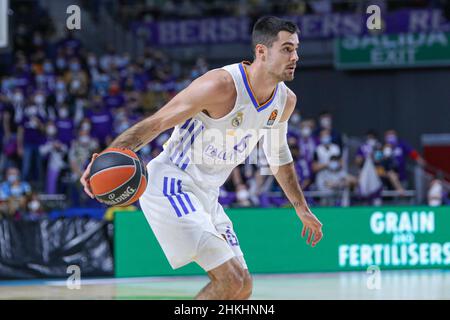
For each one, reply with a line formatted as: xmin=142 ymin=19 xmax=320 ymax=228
xmin=39 ymin=122 xmax=68 ymax=194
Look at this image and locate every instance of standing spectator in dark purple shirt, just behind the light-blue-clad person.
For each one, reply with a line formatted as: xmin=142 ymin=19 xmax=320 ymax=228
xmin=17 ymin=105 xmax=45 ymax=182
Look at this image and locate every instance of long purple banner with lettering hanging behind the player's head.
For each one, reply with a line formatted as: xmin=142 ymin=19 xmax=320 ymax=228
xmin=133 ymin=9 xmax=450 ymax=46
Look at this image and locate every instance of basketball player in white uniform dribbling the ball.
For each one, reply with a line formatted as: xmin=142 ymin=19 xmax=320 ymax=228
xmin=81 ymin=17 xmax=322 ymax=299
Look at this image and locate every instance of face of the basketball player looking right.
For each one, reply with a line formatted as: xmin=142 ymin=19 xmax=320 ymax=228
xmin=267 ymin=31 xmax=299 ymax=81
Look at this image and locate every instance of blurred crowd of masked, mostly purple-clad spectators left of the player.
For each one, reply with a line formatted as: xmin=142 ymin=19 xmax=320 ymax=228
xmin=0 ymin=15 xmax=208 ymax=218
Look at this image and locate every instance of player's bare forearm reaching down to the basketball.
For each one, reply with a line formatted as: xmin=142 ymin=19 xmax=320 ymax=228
xmin=110 ymin=118 xmax=161 ymax=152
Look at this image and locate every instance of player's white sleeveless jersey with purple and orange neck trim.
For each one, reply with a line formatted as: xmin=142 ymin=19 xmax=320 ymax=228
xmin=161 ymin=62 xmax=287 ymax=188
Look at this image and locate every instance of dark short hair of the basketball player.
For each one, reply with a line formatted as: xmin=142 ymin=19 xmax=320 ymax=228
xmin=252 ymin=16 xmax=300 ymax=48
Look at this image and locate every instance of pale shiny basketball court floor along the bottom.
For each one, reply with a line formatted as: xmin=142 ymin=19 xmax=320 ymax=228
xmin=0 ymin=270 xmax=450 ymax=300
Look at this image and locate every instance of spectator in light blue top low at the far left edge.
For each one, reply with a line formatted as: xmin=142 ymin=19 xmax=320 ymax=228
xmin=0 ymin=167 xmax=31 ymax=218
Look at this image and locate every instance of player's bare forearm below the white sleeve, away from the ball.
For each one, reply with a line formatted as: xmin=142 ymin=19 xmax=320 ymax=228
xmin=275 ymin=162 xmax=309 ymax=214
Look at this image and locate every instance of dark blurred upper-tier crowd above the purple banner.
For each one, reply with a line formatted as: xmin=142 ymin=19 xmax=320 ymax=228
xmin=105 ymin=0 xmax=450 ymax=25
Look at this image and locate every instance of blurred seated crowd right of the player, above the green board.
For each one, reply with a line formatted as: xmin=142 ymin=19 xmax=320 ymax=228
xmin=221 ymin=111 xmax=448 ymax=207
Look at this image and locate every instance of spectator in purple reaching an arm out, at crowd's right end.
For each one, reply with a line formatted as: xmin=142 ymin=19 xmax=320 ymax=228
xmin=384 ymin=129 xmax=426 ymax=186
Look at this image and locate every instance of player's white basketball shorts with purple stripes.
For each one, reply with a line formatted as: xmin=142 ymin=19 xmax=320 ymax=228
xmin=139 ymin=154 xmax=247 ymax=271
